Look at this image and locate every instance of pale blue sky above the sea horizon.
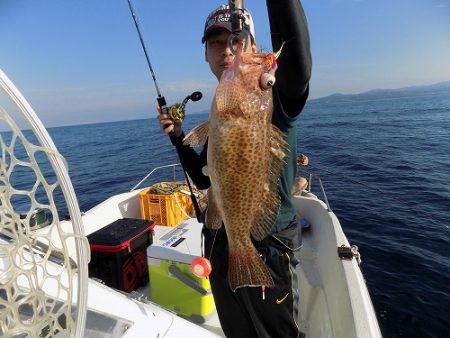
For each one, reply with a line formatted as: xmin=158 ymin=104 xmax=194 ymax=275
xmin=0 ymin=0 xmax=450 ymax=126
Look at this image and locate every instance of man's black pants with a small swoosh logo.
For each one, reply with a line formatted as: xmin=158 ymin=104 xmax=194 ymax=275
xmin=204 ymin=224 xmax=301 ymax=338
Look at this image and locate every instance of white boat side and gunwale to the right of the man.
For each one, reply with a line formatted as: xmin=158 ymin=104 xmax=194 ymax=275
xmin=294 ymin=194 xmax=381 ymax=338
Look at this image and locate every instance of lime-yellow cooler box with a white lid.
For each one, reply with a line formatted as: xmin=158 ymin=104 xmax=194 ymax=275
xmin=147 ymin=219 xmax=216 ymax=323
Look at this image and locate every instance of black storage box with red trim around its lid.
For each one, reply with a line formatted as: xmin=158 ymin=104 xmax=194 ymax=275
xmin=87 ymin=218 xmax=154 ymax=292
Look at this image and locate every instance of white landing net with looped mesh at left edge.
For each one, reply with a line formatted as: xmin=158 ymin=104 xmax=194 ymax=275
xmin=0 ymin=69 xmax=89 ymax=337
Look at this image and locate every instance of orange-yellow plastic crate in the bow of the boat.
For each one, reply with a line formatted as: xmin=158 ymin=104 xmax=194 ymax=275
xmin=138 ymin=182 xmax=193 ymax=227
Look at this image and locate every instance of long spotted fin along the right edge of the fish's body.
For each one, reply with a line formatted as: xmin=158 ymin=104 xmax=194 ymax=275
xmin=251 ymin=125 xmax=289 ymax=241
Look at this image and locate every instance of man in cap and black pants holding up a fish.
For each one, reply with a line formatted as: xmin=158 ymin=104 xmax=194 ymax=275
xmin=159 ymin=0 xmax=311 ymax=338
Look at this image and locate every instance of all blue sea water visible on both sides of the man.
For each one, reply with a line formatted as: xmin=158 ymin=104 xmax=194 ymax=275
xmin=7 ymin=93 xmax=450 ymax=338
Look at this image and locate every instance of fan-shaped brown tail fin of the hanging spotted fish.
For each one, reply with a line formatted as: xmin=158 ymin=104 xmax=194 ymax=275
xmin=228 ymin=246 xmax=275 ymax=291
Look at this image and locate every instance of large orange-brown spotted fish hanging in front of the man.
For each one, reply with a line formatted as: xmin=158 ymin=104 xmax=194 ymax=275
xmin=184 ymin=47 xmax=288 ymax=291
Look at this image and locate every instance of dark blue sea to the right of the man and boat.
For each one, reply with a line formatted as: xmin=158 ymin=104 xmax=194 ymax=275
xmin=298 ymin=94 xmax=450 ymax=337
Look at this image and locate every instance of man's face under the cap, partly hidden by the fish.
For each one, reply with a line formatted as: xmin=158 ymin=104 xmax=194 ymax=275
xmin=205 ymin=29 xmax=256 ymax=80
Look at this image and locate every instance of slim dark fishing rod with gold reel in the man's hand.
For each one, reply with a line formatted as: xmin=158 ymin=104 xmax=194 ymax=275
xmin=128 ymin=0 xmax=203 ymax=222
